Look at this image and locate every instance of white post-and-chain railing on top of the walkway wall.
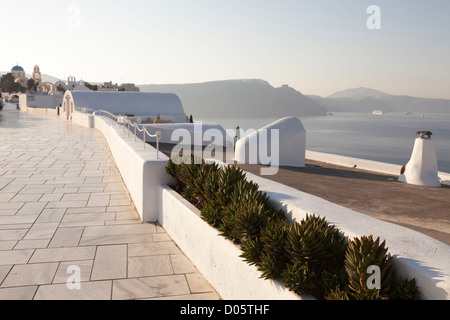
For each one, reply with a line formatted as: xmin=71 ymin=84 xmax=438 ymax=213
xmin=76 ymin=107 xmax=161 ymax=159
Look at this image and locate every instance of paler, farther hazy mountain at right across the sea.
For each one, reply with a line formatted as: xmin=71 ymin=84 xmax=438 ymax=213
xmin=308 ymin=88 xmax=450 ymax=114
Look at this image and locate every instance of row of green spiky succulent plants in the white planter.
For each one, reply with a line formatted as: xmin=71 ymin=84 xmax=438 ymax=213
xmin=166 ymin=161 xmax=418 ymax=300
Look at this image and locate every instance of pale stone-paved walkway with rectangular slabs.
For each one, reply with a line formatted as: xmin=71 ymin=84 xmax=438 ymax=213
xmin=0 ymin=110 xmax=220 ymax=300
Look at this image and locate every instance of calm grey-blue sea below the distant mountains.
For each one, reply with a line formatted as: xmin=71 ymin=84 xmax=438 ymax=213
xmin=199 ymin=112 xmax=450 ymax=173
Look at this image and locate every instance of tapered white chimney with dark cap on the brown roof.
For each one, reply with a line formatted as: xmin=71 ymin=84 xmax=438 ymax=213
xmin=398 ymin=138 xmax=441 ymax=187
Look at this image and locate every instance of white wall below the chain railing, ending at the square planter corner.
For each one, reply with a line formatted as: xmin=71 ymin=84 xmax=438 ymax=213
xmin=72 ymin=112 xmax=172 ymax=222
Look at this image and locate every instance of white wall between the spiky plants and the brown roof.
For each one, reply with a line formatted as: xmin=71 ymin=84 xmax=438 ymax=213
xmin=247 ymin=173 xmax=450 ymax=300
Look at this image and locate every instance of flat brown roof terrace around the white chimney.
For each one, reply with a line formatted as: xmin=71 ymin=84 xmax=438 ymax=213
xmin=239 ymin=159 xmax=450 ymax=245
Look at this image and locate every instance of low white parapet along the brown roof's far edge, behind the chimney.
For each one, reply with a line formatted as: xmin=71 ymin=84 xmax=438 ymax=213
xmin=306 ymin=150 xmax=450 ymax=185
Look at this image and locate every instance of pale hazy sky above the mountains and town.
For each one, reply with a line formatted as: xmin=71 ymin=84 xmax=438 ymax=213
xmin=0 ymin=0 xmax=450 ymax=99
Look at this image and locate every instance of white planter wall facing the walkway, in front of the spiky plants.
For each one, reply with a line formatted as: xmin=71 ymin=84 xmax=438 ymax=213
xmin=159 ymin=186 xmax=306 ymax=300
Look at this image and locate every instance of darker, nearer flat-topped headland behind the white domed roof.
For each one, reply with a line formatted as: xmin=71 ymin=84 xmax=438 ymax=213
xmin=139 ymin=79 xmax=327 ymax=119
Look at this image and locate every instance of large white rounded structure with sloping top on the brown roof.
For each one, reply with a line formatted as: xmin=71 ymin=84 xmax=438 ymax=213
xmin=235 ymin=117 xmax=306 ymax=167
